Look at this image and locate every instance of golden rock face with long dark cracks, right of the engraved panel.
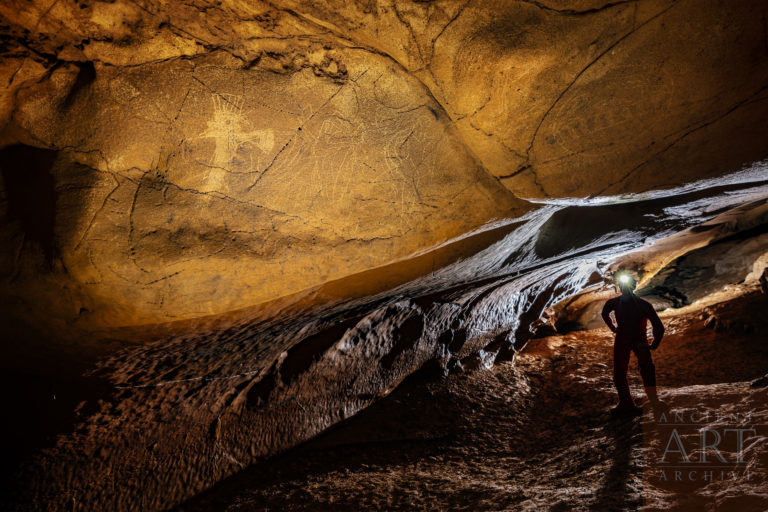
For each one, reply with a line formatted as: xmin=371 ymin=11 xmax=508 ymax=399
xmin=280 ymin=0 xmax=768 ymax=198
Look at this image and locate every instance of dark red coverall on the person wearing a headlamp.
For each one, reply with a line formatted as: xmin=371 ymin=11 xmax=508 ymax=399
xmin=602 ymin=294 xmax=664 ymax=406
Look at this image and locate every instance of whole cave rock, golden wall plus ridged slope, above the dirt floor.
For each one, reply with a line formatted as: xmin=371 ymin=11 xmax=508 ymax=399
xmin=0 ymin=0 xmax=768 ymax=510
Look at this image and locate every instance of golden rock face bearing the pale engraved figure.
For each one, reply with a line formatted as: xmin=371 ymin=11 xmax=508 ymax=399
xmin=3 ymin=2 xmax=527 ymax=328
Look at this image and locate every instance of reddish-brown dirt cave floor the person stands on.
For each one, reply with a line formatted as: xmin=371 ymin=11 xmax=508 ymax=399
xmin=179 ymin=293 xmax=768 ymax=512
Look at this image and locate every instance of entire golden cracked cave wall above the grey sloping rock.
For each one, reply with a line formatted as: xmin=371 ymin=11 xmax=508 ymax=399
xmin=0 ymin=0 xmax=768 ymax=330
